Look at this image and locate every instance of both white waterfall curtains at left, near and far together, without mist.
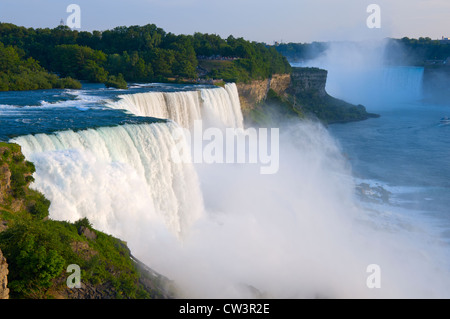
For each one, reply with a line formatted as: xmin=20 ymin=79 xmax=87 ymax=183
xmin=7 ymin=83 xmax=243 ymax=242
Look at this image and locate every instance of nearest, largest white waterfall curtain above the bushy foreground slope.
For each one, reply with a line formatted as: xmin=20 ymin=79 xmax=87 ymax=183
xmin=12 ymin=123 xmax=203 ymax=238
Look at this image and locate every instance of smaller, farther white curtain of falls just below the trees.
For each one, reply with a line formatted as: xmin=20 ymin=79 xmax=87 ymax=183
xmin=108 ymin=83 xmax=243 ymax=128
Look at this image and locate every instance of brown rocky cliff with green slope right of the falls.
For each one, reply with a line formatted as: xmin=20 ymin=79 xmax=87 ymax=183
xmin=238 ymin=68 xmax=378 ymax=125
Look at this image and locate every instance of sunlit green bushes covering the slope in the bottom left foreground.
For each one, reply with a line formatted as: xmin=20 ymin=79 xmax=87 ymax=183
xmin=0 ymin=219 xmax=155 ymax=298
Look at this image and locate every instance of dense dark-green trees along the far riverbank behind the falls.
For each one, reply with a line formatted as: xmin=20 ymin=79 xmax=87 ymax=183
xmin=0 ymin=23 xmax=290 ymax=89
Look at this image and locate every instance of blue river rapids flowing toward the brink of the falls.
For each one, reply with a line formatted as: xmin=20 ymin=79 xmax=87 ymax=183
xmin=0 ymin=83 xmax=214 ymax=141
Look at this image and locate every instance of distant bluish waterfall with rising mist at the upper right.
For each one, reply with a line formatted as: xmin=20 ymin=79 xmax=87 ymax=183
xmin=301 ymin=40 xmax=424 ymax=108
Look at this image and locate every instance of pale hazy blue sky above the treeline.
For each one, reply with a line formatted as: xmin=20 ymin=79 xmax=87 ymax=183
xmin=0 ymin=0 xmax=450 ymax=44
